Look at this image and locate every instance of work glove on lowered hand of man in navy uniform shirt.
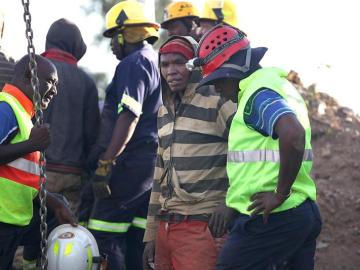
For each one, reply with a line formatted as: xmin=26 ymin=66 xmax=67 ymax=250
xmin=92 ymin=160 xmax=114 ymax=199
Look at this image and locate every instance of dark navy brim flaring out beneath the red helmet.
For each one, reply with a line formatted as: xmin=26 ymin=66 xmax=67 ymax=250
xmin=197 ymin=47 xmax=267 ymax=88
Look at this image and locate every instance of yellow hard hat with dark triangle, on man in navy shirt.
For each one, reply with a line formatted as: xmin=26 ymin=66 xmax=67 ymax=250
xmin=103 ymin=0 xmax=160 ymax=39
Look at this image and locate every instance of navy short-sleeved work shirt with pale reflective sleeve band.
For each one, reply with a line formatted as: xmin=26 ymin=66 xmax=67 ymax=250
xmin=100 ymin=44 xmax=162 ymax=152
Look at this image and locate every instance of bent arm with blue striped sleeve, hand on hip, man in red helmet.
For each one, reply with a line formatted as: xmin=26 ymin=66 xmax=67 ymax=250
xmin=244 ymin=88 xmax=305 ymax=222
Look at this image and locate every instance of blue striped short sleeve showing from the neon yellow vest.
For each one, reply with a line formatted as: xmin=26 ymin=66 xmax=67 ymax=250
xmin=244 ymin=88 xmax=295 ymax=139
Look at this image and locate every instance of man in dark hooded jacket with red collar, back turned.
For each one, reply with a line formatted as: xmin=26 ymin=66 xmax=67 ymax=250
xmin=42 ymin=19 xmax=100 ymax=213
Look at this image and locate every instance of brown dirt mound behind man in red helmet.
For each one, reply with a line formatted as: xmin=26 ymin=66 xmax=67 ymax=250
xmin=288 ymin=72 xmax=360 ymax=270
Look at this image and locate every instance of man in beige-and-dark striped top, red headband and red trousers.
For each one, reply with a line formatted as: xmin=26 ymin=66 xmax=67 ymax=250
xmin=144 ymin=36 xmax=236 ymax=270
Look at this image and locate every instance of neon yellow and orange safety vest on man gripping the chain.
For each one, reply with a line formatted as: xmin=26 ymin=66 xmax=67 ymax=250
xmin=0 ymin=92 xmax=40 ymax=226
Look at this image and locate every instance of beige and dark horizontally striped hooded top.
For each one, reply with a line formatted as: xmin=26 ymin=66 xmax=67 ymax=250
xmin=144 ymin=83 xmax=236 ymax=242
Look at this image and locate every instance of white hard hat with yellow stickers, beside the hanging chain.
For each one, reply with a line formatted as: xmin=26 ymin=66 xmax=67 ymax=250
xmin=47 ymin=224 xmax=101 ymax=270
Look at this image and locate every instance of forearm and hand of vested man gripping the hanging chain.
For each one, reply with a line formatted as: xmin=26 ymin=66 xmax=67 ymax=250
xmin=0 ymin=125 xmax=50 ymax=165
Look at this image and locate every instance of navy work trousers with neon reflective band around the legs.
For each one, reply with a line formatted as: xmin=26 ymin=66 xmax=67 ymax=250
xmin=88 ymin=192 xmax=150 ymax=270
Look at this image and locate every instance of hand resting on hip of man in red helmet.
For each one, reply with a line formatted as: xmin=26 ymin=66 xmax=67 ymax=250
xmin=247 ymin=192 xmax=287 ymax=224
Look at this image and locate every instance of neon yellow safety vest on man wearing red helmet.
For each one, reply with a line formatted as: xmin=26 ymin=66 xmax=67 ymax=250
xmin=226 ymin=68 xmax=316 ymax=214
